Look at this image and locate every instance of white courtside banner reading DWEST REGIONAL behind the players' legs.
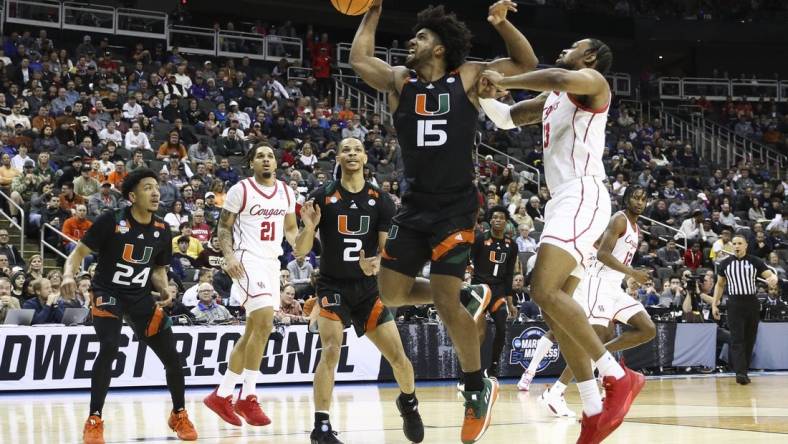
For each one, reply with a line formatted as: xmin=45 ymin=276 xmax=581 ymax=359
xmin=0 ymin=325 xmax=381 ymax=391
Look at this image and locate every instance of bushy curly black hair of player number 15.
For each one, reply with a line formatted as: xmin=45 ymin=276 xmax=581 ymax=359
xmin=413 ymin=5 xmax=473 ymax=71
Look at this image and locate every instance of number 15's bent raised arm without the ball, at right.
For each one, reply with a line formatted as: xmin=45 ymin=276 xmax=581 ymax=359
xmin=478 ymin=0 xmax=539 ymax=76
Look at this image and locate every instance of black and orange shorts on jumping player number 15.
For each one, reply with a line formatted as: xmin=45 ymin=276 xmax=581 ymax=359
xmin=381 ymin=211 xmax=476 ymax=279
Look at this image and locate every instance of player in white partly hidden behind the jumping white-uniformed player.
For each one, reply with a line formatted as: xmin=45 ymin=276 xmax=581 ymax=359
xmin=532 ymin=185 xmax=656 ymax=417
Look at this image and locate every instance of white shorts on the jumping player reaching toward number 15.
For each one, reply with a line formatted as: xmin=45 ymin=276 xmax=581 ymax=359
xmin=540 ymin=176 xmax=610 ymax=280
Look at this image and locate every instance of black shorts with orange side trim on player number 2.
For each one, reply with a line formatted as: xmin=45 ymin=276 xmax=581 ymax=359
xmin=316 ymin=274 xmax=394 ymax=337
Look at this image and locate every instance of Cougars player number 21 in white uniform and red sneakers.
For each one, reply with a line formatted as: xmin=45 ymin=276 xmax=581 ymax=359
xmin=204 ymin=145 xmax=304 ymax=426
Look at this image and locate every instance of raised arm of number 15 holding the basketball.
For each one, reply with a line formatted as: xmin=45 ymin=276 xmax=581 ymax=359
xmin=350 ymin=0 xmax=407 ymax=93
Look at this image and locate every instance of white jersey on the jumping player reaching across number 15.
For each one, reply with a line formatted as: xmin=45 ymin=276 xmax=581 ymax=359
xmin=542 ymin=91 xmax=610 ymax=192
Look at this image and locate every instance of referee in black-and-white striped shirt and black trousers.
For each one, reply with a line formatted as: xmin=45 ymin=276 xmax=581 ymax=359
xmin=711 ymin=235 xmax=777 ymax=385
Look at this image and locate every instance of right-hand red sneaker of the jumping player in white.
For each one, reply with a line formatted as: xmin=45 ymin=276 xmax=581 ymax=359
xmin=595 ymin=366 xmax=646 ymax=441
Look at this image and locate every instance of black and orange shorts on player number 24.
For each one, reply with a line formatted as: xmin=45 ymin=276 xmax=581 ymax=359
xmin=90 ymin=287 xmax=172 ymax=339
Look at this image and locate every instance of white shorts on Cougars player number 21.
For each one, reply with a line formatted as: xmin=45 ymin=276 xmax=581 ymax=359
xmin=230 ymin=250 xmax=280 ymax=316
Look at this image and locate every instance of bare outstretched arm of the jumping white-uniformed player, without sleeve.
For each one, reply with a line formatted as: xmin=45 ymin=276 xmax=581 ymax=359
xmin=482 ymin=68 xmax=610 ymax=96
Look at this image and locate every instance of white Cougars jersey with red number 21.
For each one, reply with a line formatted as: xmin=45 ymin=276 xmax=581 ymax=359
xmin=223 ymin=177 xmax=296 ymax=259
